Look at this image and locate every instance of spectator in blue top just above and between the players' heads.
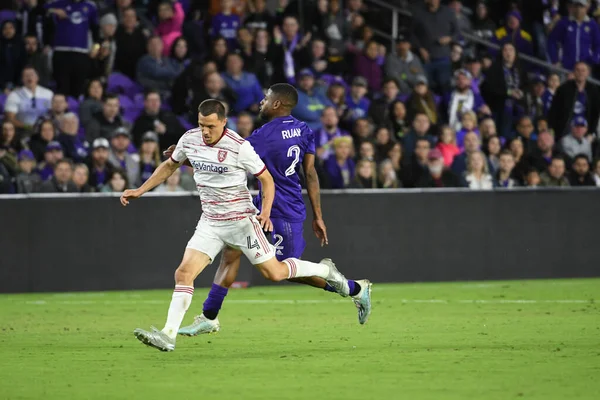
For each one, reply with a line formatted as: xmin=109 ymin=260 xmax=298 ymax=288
xmin=223 ymin=53 xmax=264 ymax=114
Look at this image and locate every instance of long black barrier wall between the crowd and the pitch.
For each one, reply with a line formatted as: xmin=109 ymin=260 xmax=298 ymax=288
xmin=0 ymin=189 xmax=600 ymax=293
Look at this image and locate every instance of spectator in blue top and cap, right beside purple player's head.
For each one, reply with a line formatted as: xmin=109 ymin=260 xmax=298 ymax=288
xmin=292 ymin=69 xmax=334 ymax=131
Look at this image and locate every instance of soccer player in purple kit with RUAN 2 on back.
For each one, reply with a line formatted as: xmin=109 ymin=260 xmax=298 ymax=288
xmin=173 ymin=83 xmax=371 ymax=336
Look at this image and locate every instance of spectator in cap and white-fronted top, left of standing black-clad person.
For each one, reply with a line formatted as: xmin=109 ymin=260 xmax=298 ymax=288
xmin=444 ymin=69 xmax=491 ymax=131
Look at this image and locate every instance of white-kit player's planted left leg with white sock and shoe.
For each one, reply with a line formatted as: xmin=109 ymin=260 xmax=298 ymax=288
xmin=134 ymin=248 xmax=211 ymax=351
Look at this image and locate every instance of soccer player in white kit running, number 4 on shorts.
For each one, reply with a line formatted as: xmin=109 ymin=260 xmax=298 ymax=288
xmin=121 ymin=99 xmax=349 ymax=351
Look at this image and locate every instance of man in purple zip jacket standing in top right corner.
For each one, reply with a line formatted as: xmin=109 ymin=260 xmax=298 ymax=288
xmin=548 ymin=0 xmax=600 ymax=70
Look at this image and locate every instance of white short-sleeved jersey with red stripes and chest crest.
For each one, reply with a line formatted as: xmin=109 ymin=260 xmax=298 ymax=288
xmin=171 ymin=128 xmax=267 ymax=222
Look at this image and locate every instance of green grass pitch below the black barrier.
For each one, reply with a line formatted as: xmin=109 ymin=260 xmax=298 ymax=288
xmin=0 ymin=279 xmax=600 ymax=400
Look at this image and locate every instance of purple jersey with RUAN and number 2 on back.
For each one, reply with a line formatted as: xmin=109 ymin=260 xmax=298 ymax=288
xmin=247 ymin=116 xmax=315 ymax=222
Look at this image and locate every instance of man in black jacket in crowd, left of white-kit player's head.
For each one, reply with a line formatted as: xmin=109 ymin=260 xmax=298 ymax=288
xmin=130 ymin=90 xmax=184 ymax=151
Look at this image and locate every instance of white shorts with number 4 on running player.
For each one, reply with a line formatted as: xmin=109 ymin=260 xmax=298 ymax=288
xmin=187 ymin=216 xmax=275 ymax=265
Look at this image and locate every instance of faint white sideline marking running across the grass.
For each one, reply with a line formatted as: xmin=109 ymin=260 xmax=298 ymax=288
xmin=16 ymin=298 xmax=595 ymax=305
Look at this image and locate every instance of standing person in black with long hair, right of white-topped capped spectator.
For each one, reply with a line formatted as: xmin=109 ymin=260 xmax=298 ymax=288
xmin=481 ymin=43 xmax=527 ymax=138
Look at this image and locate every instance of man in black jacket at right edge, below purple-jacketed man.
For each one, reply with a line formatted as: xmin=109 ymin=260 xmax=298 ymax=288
xmin=548 ymin=62 xmax=600 ymax=140
